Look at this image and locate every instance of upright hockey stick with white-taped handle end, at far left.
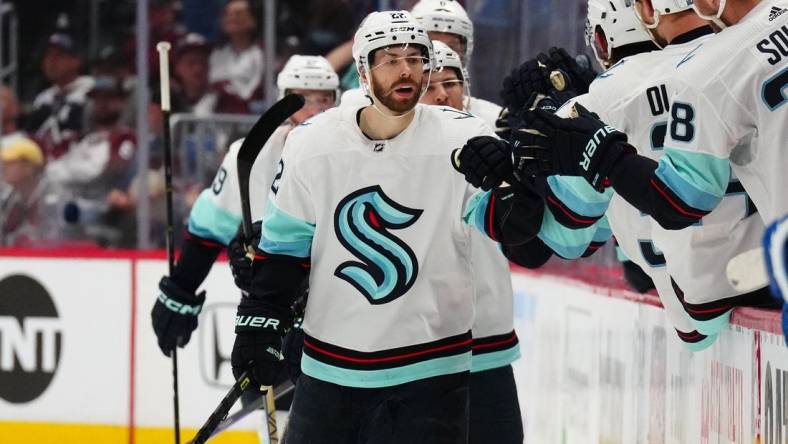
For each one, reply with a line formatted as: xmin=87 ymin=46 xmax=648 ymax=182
xmin=156 ymin=42 xmax=181 ymax=444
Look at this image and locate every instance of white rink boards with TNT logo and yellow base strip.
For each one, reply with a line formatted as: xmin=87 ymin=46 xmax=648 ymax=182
xmin=0 ymin=251 xmax=788 ymax=444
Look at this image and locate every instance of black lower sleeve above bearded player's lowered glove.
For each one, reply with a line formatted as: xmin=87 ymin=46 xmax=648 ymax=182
xmin=249 ymin=255 xmax=309 ymax=310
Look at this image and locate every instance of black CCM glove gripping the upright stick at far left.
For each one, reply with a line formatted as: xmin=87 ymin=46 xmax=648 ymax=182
xmin=151 ymin=276 xmax=205 ymax=356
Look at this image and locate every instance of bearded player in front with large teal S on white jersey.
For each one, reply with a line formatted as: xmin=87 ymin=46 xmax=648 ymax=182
xmin=232 ymin=11 xmax=543 ymax=443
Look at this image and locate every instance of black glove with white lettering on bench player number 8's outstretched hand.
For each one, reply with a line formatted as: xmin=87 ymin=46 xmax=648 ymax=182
xmin=512 ymin=104 xmax=635 ymax=192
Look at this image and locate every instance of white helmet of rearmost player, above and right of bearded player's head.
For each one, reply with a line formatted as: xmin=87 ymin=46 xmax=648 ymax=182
xmin=411 ymin=0 xmax=473 ymax=63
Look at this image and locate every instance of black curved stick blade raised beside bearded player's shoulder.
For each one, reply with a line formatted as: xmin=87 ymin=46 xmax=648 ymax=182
xmin=236 ymin=94 xmax=304 ymax=239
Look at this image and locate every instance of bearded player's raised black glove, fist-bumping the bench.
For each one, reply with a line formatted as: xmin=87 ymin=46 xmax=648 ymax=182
xmin=452 ymin=136 xmax=512 ymax=191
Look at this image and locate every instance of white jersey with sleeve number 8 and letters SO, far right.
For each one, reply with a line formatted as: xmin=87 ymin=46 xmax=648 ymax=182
xmin=660 ymin=0 xmax=788 ymax=223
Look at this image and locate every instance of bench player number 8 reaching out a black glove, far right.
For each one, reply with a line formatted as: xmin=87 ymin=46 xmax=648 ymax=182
xmin=508 ymin=1 xmax=788 ymax=332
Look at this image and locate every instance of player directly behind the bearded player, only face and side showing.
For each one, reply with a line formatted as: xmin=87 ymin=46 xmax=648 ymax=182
xmin=421 ymin=40 xmax=523 ymax=444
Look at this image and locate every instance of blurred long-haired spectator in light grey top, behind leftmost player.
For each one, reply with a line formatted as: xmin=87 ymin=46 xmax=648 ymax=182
xmin=210 ymin=0 xmax=264 ymax=113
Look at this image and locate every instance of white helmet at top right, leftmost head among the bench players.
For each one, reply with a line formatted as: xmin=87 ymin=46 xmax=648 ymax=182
xmin=586 ymin=0 xmax=651 ymax=68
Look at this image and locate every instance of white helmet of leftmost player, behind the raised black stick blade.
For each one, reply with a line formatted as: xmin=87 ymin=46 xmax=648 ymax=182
xmin=276 ymin=55 xmax=339 ymax=100
